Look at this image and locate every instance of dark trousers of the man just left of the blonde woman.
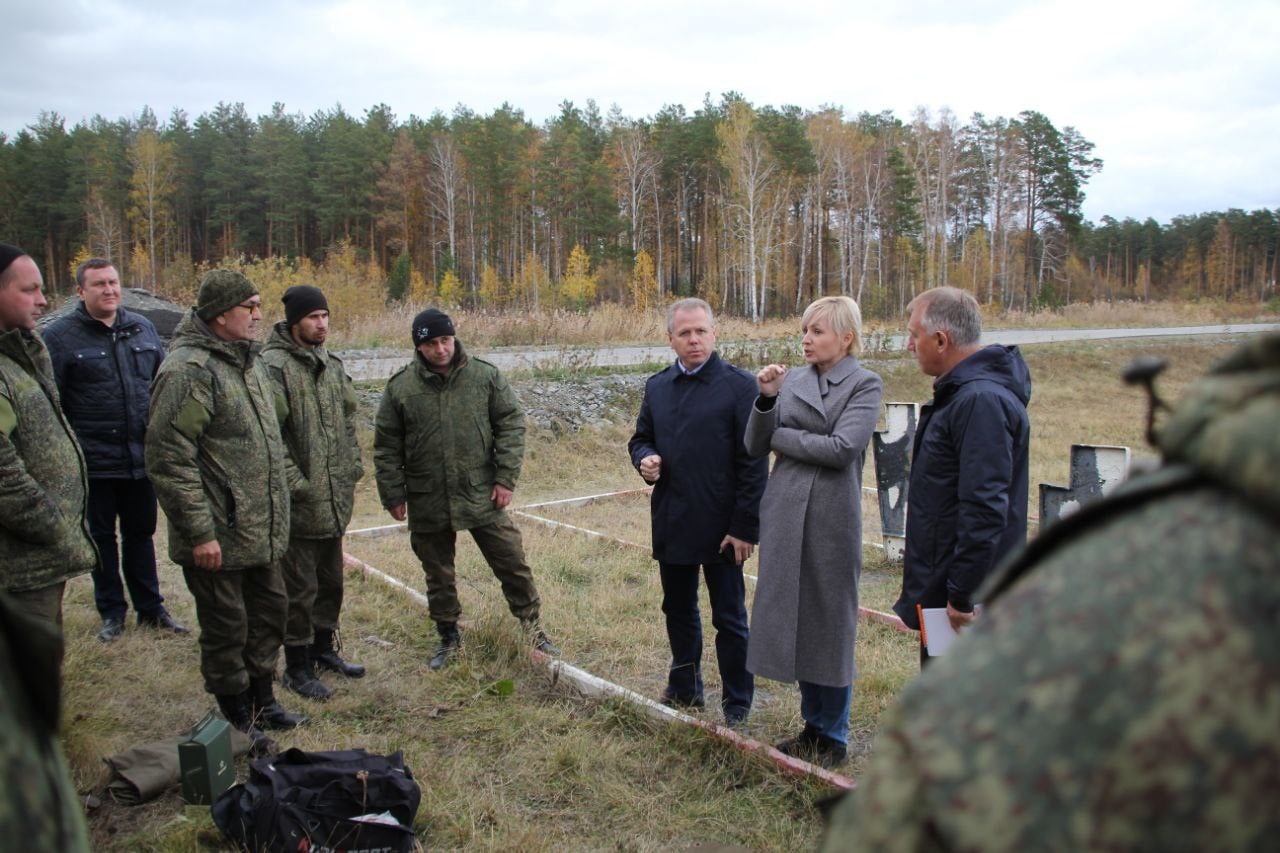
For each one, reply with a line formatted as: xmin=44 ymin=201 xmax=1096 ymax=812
xmin=658 ymin=562 xmax=755 ymax=713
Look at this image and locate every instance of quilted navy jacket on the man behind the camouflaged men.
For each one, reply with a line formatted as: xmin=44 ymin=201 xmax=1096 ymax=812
xmin=41 ymin=302 xmax=165 ymax=479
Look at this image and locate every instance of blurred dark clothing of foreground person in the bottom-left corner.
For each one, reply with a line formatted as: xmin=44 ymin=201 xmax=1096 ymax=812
xmin=0 ymin=594 xmax=90 ymax=853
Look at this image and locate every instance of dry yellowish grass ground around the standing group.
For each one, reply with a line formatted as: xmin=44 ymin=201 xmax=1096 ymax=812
xmin=63 ymin=329 xmax=1259 ymax=850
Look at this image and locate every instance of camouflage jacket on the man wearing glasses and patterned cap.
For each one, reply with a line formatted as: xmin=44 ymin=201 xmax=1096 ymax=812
xmin=147 ymin=311 xmax=289 ymax=569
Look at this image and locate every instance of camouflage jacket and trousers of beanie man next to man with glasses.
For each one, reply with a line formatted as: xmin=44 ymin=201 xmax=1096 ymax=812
xmin=262 ymin=321 xmax=365 ymax=646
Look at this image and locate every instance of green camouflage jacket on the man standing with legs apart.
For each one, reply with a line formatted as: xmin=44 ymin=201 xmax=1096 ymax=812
xmin=374 ymin=343 xmax=525 ymax=533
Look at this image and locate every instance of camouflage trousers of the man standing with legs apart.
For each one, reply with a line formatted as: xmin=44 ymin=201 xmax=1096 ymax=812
xmin=410 ymin=515 xmax=541 ymax=622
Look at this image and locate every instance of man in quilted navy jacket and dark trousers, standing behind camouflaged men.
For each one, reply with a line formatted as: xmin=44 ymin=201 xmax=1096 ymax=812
xmin=44 ymin=257 xmax=188 ymax=643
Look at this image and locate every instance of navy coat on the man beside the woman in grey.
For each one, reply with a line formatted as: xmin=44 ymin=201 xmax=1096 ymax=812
xmin=627 ymin=352 xmax=768 ymax=565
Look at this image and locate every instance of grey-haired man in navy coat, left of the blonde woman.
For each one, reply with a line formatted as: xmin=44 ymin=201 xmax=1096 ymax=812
xmin=627 ymin=298 xmax=768 ymax=726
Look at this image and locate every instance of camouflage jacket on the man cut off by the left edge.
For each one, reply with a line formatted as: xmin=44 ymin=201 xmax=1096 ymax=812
xmin=0 ymin=329 xmax=97 ymax=592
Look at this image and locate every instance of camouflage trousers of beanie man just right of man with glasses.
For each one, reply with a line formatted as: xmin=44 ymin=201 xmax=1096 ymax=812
xmin=280 ymin=537 xmax=342 ymax=646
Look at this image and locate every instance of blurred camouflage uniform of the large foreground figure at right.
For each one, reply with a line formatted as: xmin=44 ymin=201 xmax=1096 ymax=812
xmin=826 ymin=334 xmax=1280 ymax=850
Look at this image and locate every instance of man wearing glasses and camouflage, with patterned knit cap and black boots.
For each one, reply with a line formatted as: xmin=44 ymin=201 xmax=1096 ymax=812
xmin=146 ymin=269 xmax=307 ymax=754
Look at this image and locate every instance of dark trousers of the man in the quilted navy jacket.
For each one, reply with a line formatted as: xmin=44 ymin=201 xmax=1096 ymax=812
xmin=88 ymin=478 xmax=164 ymax=620
